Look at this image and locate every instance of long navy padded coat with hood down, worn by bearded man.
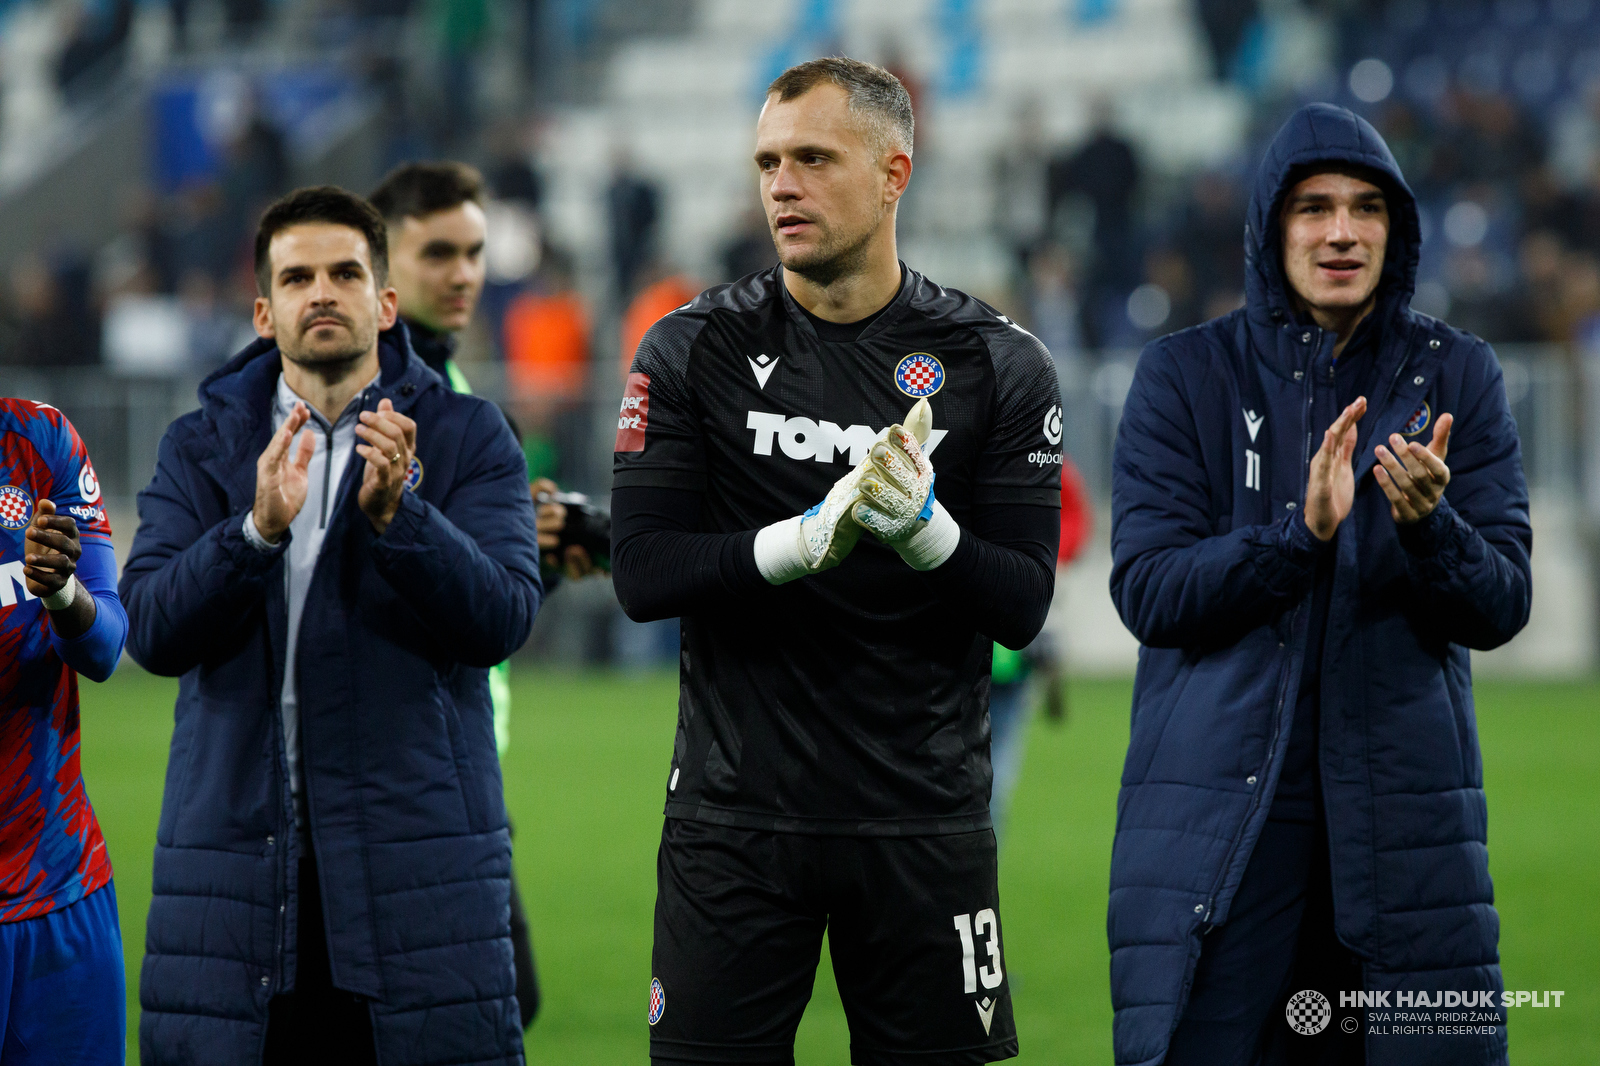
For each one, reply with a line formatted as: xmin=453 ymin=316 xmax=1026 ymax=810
xmin=120 ymin=327 xmax=542 ymax=1066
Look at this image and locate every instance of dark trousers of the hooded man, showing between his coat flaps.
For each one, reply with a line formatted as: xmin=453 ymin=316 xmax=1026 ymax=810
xmin=1165 ymin=820 xmax=1366 ymax=1066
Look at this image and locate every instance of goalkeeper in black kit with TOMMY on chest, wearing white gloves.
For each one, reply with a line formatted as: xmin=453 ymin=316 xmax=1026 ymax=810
xmin=611 ymin=58 xmax=1061 ymax=1066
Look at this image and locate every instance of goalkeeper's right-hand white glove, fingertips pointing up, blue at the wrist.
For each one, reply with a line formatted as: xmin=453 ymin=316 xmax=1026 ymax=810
xmin=851 ymin=400 xmax=962 ymax=570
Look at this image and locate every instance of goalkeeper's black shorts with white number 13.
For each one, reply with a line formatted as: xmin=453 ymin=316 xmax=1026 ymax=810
xmin=650 ymin=818 xmax=1016 ymax=1066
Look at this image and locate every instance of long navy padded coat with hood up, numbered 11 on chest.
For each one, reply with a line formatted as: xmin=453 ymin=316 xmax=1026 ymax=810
xmin=1107 ymin=104 xmax=1533 ymax=1066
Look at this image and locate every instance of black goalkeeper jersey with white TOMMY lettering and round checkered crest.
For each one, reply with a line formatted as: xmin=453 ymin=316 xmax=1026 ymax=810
xmin=614 ymin=267 xmax=1061 ymax=836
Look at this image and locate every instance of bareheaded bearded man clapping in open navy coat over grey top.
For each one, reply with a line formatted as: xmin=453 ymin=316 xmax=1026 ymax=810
xmin=120 ymin=187 xmax=542 ymax=1066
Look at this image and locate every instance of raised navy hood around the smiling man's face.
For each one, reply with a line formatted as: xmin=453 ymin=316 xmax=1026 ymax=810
xmin=1245 ymin=104 xmax=1422 ymax=328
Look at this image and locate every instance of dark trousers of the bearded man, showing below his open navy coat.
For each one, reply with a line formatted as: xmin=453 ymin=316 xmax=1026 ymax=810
xmin=261 ymin=847 xmax=378 ymax=1066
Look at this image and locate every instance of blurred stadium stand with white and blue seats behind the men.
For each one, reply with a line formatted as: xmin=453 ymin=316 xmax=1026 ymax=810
xmin=0 ymin=0 xmax=1600 ymax=669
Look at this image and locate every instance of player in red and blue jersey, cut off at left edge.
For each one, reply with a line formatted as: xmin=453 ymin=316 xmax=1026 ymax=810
xmin=0 ymin=399 xmax=128 ymax=1066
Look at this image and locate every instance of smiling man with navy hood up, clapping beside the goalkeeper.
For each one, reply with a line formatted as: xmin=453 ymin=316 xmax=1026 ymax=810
xmin=1107 ymin=104 xmax=1533 ymax=1066
